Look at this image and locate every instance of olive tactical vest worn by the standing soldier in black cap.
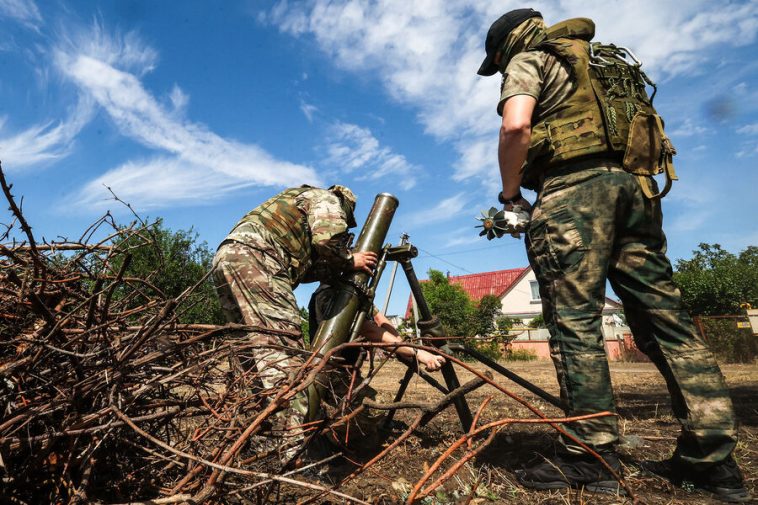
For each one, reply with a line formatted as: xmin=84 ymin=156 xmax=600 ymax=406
xmin=522 ymin=20 xmax=677 ymax=198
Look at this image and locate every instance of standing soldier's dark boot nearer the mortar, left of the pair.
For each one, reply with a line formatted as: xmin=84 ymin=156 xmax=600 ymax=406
xmin=516 ymin=452 xmax=624 ymax=494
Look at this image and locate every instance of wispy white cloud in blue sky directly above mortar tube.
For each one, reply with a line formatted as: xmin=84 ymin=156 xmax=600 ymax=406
xmin=326 ymin=122 xmax=421 ymax=190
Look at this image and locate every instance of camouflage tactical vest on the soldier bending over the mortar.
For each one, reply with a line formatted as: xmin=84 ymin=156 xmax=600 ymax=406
xmin=232 ymin=185 xmax=313 ymax=285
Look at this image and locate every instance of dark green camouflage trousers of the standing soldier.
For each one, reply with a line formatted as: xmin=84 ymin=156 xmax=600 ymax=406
xmin=526 ymin=162 xmax=736 ymax=468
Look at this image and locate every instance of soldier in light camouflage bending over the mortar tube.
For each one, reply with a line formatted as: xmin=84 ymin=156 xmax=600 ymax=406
xmin=213 ymin=186 xmax=376 ymax=462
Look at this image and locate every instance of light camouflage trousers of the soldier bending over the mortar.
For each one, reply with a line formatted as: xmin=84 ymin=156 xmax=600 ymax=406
xmin=213 ymin=241 xmax=308 ymax=461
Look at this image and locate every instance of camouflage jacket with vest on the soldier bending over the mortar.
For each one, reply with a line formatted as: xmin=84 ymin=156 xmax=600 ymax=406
xmin=226 ymin=186 xmax=353 ymax=288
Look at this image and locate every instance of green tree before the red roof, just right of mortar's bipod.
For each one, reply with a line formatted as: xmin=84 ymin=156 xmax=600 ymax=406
xmin=421 ymin=269 xmax=475 ymax=337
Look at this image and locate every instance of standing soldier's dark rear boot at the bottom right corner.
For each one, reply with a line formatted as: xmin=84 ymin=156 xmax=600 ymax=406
xmin=640 ymin=455 xmax=752 ymax=503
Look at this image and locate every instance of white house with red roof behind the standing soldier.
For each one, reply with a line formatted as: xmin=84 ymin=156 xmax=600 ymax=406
xmin=406 ymin=267 xmax=633 ymax=359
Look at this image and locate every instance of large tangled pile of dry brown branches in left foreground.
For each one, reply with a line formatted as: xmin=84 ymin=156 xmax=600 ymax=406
xmin=0 ymin=163 xmax=632 ymax=504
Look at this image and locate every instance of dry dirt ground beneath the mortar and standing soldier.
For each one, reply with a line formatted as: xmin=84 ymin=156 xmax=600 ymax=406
xmin=318 ymin=362 xmax=758 ymax=504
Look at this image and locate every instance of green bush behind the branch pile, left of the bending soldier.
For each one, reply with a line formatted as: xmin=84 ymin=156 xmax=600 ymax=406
xmin=112 ymin=219 xmax=225 ymax=324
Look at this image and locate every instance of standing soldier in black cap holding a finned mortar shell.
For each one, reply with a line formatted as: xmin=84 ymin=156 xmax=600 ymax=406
xmin=478 ymin=9 xmax=750 ymax=501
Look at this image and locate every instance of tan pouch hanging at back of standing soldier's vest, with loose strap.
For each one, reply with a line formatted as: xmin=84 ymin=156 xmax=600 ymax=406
xmin=623 ymin=111 xmax=678 ymax=199
